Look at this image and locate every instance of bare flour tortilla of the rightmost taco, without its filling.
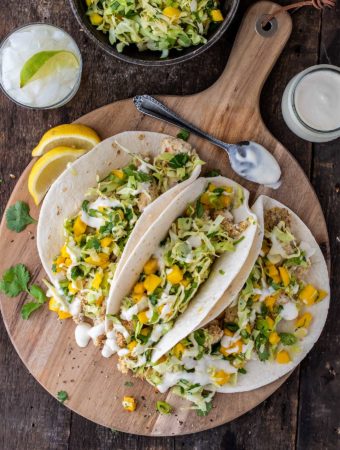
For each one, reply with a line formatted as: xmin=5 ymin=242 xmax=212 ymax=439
xmin=217 ymin=195 xmax=330 ymax=393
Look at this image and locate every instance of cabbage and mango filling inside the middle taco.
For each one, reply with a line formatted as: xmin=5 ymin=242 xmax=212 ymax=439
xmin=104 ymin=184 xmax=249 ymax=376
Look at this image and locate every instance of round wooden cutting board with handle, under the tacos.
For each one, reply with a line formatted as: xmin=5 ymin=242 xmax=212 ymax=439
xmin=0 ymin=2 xmax=329 ymax=435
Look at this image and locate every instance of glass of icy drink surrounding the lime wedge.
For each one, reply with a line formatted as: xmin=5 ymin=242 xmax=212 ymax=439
xmin=0 ymin=23 xmax=82 ymax=109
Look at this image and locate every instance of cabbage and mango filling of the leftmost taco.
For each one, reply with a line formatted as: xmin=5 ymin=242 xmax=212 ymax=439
xmin=43 ymin=138 xmax=202 ymax=326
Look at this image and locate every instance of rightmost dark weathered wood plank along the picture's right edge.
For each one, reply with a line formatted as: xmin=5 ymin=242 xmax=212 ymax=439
xmin=297 ymin=4 xmax=340 ymax=450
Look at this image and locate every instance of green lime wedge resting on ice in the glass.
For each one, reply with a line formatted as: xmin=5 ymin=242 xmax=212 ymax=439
xmin=20 ymin=50 xmax=79 ymax=88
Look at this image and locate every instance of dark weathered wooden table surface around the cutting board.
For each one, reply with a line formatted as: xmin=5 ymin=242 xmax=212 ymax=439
xmin=0 ymin=0 xmax=340 ymax=450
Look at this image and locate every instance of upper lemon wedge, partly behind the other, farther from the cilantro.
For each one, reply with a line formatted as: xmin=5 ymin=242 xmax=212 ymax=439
xmin=32 ymin=123 xmax=100 ymax=156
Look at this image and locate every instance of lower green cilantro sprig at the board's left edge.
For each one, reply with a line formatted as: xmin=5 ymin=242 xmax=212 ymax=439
xmin=0 ymin=264 xmax=47 ymax=320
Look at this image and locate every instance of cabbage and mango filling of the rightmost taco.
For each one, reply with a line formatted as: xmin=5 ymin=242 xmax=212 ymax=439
xmin=141 ymin=207 xmax=328 ymax=414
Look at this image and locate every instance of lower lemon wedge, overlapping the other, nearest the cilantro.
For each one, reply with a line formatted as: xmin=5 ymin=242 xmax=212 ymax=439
xmin=28 ymin=147 xmax=87 ymax=205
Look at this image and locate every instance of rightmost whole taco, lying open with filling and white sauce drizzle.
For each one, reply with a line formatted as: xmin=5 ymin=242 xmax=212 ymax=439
xmin=139 ymin=196 xmax=330 ymax=414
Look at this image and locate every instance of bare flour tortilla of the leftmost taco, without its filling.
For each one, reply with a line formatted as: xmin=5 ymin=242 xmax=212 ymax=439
xmin=37 ymin=131 xmax=201 ymax=283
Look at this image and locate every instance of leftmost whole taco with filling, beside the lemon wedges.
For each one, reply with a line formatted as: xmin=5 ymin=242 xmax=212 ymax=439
xmin=37 ymin=132 xmax=203 ymax=330
